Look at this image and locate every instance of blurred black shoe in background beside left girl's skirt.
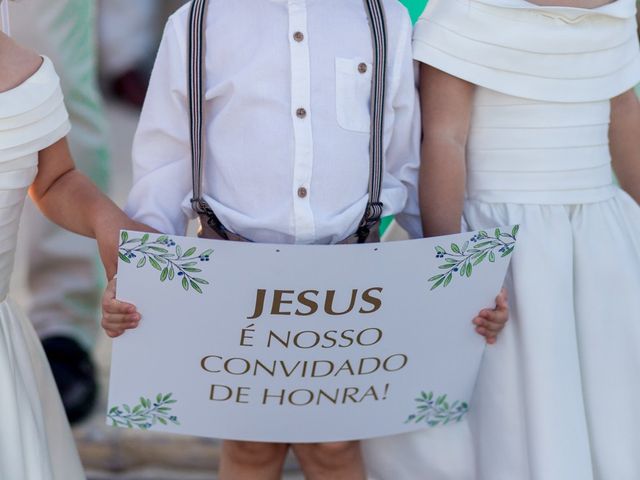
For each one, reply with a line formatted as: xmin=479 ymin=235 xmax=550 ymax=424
xmin=42 ymin=336 xmax=98 ymax=423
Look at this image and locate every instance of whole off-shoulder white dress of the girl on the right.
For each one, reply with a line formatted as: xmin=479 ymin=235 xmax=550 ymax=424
xmin=365 ymin=0 xmax=640 ymax=480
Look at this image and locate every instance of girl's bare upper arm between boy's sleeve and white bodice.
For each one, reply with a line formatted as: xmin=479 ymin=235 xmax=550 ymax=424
xmin=419 ymin=64 xmax=475 ymax=237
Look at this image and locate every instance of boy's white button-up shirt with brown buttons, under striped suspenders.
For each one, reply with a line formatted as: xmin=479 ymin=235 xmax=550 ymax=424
xmin=127 ymin=0 xmax=421 ymax=243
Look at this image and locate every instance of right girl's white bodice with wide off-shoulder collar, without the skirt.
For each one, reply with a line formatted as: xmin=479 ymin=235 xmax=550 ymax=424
xmin=414 ymin=0 xmax=640 ymax=205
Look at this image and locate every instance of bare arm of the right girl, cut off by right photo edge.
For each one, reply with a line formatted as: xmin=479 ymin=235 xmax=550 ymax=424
xmin=609 ymin=90 xmax=640 ymax=203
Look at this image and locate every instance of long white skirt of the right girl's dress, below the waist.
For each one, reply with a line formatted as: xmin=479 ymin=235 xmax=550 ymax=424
xmin=364 ymin=187 xmax=640 ymax=480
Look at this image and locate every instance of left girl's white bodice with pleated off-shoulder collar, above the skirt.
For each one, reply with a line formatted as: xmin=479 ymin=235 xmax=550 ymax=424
xmin=0 ymin=58 xmax=70 ymax=302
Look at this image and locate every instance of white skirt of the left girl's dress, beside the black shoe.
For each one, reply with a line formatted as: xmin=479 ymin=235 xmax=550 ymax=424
xmin=0 ymin=300 xmax=86 ymax=480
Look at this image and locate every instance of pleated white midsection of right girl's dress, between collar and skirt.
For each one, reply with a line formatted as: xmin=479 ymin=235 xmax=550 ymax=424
xmin=467 ymin=87 xmax=616 ymax=205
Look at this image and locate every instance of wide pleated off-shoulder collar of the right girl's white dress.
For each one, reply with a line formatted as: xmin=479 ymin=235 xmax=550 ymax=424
xmin=413 ymin=0 xmax=640 ymax=103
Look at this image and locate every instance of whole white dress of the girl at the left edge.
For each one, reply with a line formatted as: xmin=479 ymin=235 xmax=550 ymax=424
xmin=0 ymin=58 xmax=85 ymax=480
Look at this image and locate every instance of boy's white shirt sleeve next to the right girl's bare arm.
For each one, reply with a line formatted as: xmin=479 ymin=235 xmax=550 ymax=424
xmin=386 ymin=12 xmax=423 ymax=238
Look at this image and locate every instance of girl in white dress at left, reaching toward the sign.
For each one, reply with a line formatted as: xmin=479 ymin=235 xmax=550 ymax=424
xmin=0 ymin=1 xmax=150 ymax=480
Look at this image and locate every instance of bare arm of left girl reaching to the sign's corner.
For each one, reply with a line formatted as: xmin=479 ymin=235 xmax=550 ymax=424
xmin=29 ymin=139 xmax=156 ymax=278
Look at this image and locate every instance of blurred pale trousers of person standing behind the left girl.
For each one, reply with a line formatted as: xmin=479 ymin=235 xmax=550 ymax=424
xmin=11 ymin=0 xmax=108 ymax=347
